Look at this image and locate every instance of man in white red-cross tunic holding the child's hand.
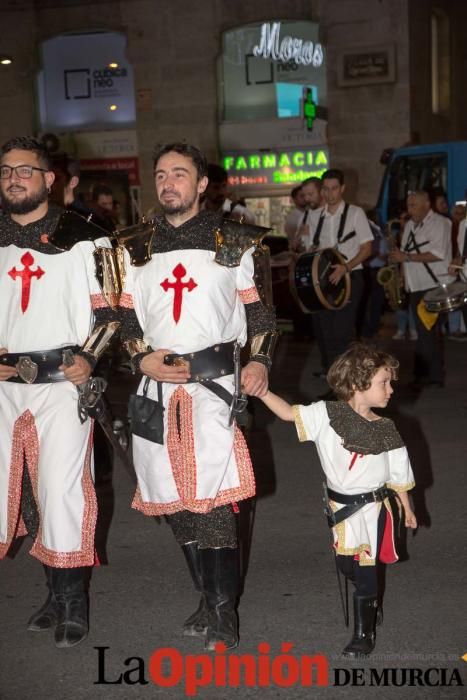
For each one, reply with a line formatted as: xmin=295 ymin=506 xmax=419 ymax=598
xmin=121 ymin=143 xmax=276 ymax=650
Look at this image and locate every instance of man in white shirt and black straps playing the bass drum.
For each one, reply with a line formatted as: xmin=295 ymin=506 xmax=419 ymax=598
xmin=306 ymin=170 xmax=373 ymax=388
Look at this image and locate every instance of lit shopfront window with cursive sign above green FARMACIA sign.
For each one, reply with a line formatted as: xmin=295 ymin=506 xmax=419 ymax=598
xmin=218 ymin=19 xmax=328 ymax=183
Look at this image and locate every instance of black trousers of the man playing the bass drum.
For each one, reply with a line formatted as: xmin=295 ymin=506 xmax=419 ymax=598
xmin=313 ymin=270 xmax=364 ymax=372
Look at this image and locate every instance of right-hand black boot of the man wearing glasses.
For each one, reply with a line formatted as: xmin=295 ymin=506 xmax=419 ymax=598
xmin=52 ymin=567 xmax=88 ymax=648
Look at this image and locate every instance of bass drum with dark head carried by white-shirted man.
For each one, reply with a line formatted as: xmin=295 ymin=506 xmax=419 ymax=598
xmin=290 ymin=248 xmax=350 ymax=313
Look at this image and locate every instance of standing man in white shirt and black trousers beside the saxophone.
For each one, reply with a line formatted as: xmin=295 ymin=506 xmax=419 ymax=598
xmin=389 ymin=191 xmax=452 ymax=388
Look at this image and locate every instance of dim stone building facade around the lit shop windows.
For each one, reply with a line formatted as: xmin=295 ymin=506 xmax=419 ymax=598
xmin=0 ymin=0 xmax=467 ymax=219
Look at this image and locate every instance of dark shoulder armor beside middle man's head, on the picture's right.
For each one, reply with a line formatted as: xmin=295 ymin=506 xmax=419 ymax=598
xmin=214 ymin=219 xmax=271 ymax=267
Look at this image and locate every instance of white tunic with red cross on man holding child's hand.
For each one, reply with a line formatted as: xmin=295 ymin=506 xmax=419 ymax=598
xmin=121 ymin=249 xmax=259 ymax=515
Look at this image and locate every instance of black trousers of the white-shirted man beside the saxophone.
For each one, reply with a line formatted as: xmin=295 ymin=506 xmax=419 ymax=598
xmin=409 ymin=290 xmax=444 ymax=382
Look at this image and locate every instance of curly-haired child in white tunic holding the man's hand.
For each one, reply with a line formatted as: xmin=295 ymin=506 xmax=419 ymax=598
xmin=261 ymin=344 xmax=417 ymax=658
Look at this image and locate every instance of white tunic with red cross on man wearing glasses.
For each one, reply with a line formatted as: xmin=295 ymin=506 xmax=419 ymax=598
xmin=0 ymin=230 xmax=109 ymax=567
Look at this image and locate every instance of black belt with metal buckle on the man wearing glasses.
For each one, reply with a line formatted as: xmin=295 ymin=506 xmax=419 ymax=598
xmin=0 ymin=345 xmax=79 ymax=384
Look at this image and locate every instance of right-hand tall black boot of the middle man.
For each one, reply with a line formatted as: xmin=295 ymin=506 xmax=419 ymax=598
xmin=199 ymin=547 xmax=239 ymax=651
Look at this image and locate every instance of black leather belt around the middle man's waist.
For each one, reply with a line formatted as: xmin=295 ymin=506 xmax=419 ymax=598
xmin=164 ymin=341 xmax=235 ymax=384
